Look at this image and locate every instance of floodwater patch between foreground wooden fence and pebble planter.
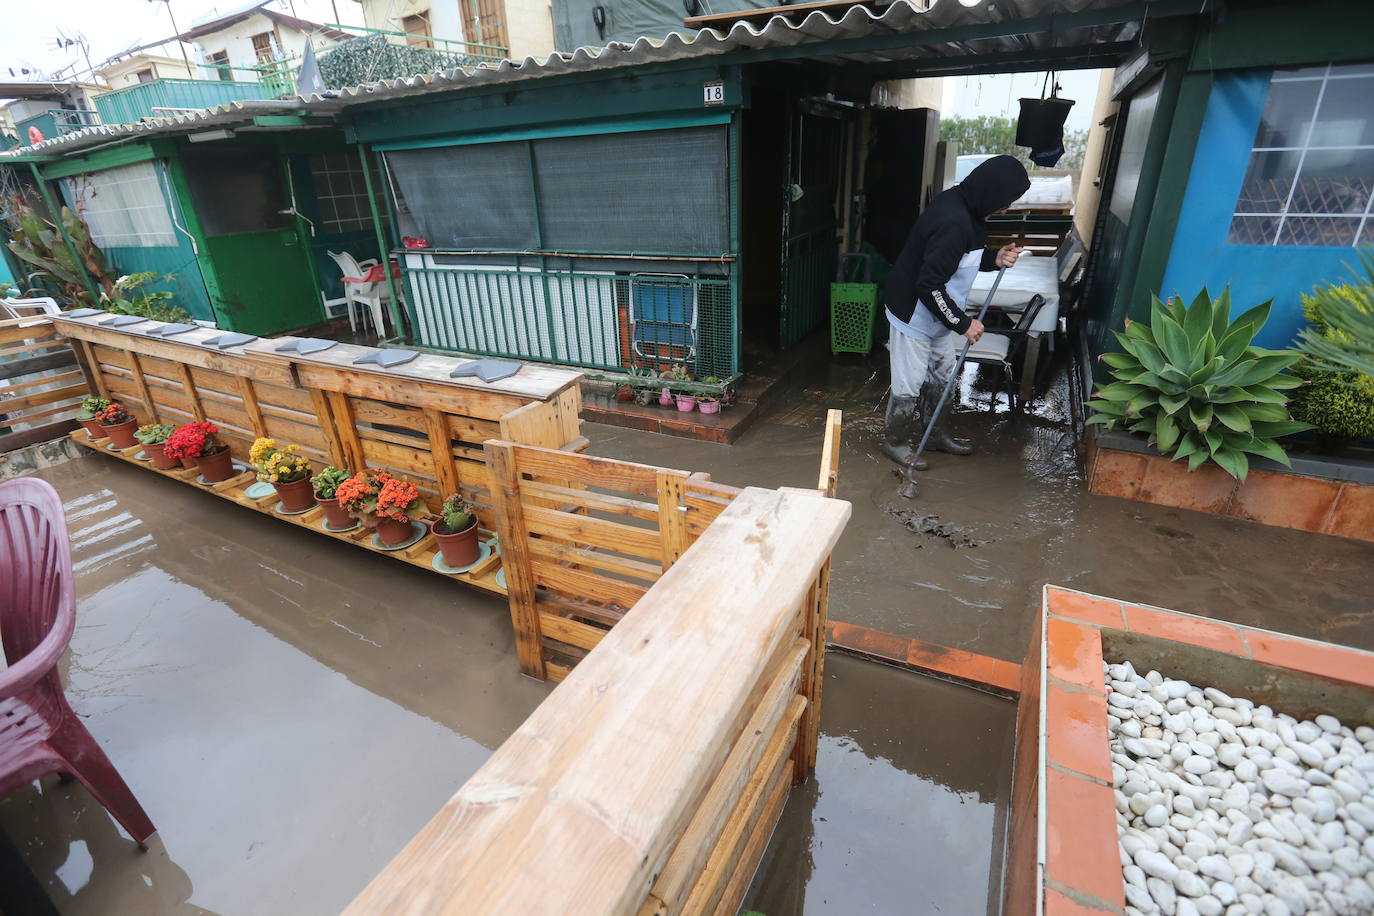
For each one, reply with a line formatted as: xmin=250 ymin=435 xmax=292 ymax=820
xmin=745 ymin=652 xmax=1017 ymax=916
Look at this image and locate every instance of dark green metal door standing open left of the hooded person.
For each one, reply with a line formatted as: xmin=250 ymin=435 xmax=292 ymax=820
xmin=779 ymin=100 xmax=845 ymax=347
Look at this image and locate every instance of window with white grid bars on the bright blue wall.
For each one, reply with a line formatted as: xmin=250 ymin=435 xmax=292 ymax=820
xmin=1228 ymin=63 xmax=1374 ymax=247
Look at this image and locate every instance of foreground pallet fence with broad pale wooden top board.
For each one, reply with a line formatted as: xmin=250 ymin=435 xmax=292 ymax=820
xmin=346 ymin=491 xmax=849 ymax=916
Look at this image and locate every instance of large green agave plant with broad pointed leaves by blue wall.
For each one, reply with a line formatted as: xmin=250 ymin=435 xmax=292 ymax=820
xmin=1088 ymin=288 xmax=1312 ymax=481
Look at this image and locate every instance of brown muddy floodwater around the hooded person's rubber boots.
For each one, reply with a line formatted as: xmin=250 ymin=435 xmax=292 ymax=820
xmin=596 ymin=357 xmax=1374 ymax=662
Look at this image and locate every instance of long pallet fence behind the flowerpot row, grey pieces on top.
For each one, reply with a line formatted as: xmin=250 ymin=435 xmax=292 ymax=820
xmin=49 ymin=316 xmax=585 ymax=526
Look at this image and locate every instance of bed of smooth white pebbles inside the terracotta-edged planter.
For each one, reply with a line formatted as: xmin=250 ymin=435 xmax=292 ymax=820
xmin=1103 ymin=662 xmax=1374 ymax=916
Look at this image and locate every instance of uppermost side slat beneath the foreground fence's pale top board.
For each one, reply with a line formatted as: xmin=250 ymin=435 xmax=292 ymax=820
xmin=640 ymin=639 xmax=811 ymax=916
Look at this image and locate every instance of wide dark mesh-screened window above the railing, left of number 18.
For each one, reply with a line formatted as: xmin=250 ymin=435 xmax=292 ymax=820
xmin=386 ymin=126 xmax=730 ymax=255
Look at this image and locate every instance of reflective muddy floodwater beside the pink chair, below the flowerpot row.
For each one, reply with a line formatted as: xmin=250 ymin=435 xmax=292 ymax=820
xmin=0 ymin=456 xmax=551 ymax=916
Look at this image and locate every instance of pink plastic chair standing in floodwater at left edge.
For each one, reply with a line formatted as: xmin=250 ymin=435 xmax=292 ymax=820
xmin=0 ymin=478 xmax=155 ymax=850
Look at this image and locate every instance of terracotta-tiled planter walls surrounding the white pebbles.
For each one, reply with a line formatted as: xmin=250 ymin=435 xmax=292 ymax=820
xmin=1003 ymin=586 xmax=1374 ymax=916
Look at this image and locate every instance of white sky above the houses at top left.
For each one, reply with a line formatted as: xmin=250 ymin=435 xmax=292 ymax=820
xmin=0 ymin=0 xmax=363 ymax=80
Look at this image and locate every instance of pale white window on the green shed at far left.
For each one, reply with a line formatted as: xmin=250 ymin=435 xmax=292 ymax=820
xmin=66 ymin=162 xmax=177 ymax=249
